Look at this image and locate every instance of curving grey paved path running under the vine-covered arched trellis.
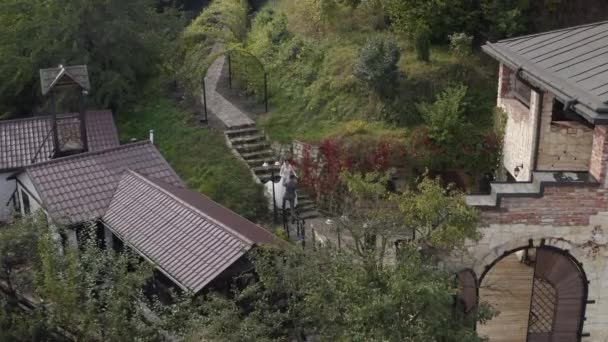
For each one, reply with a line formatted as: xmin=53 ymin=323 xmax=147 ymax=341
xmin=201 ymin=44 xmax=255 ymax=129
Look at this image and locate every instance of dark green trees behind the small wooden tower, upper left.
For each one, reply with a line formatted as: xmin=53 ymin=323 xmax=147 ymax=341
xmin=0 ymin=0 xmax=180 ymax=114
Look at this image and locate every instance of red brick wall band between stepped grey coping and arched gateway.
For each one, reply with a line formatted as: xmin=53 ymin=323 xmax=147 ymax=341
xmin=482 ymin=184 xmax=608 ymax=226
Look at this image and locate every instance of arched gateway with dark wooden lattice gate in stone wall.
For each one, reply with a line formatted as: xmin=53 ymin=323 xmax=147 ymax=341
xmin=477 ymin=243 xmax=587 ymax=342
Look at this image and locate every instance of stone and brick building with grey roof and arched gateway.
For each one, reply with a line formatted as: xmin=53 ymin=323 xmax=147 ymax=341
xmin=458 ymin=22 xmax=608 ymax=341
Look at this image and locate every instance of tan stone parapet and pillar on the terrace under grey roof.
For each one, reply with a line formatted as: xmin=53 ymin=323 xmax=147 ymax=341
xmin=538 ymin=93 xmax=593 ymax=171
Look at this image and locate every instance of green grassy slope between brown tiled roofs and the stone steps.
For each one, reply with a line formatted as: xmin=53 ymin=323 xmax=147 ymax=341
xmin=118 ymin=97 xmax=267 ymax=221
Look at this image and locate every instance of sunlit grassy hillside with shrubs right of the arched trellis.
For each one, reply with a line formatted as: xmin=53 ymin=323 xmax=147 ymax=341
xmin=246 ymin=1 xmax=496 ymax=142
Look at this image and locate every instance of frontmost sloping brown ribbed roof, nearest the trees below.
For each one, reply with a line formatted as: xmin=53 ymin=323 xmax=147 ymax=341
xmin=103 ymin=171 xmax=273 ymax=293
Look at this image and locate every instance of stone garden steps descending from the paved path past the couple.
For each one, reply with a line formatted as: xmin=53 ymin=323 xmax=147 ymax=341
xmin=224 ymin=124 xmax=319 ymax=220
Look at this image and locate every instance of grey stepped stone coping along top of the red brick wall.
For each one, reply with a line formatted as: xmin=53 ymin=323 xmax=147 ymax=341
xmin=466 ymin=171 xmax=595 ymax=208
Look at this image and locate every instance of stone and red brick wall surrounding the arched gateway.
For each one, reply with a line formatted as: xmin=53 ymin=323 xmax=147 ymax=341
xmin=454 ymin=184 xmax=608 ymax=341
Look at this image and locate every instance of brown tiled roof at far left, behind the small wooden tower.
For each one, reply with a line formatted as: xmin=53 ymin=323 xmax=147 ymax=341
xmin=0 ymin=111 xmax=119 ymax=171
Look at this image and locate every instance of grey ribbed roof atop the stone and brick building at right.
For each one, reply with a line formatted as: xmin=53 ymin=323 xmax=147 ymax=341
xmin=483 ymin=22 xmax=608 ymax=122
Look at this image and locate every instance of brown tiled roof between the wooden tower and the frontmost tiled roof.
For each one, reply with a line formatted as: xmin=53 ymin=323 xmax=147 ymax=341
xmin=25 ymin=141 xmax=182 ymax=224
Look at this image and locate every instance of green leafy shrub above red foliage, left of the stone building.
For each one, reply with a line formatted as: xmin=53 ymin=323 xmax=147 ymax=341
xmin=418 ymin=85 xmax=467 ymax=147
